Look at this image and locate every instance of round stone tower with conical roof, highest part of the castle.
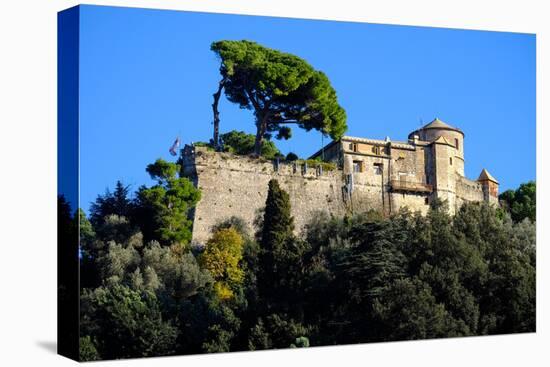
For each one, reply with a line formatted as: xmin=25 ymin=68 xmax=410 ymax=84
xmin=409 ymin=118 xmax=464 ymax=176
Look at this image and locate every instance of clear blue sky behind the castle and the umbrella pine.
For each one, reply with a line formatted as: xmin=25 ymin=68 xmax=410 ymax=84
xmin=76 ymin=6 xmax=536 ymax=211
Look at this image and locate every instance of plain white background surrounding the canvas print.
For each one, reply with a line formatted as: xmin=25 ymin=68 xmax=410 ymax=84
xmin=0 ymin=0 xmax=550 ymax=367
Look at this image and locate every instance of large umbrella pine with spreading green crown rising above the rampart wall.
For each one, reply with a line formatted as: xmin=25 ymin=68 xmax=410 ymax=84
xmin=211 ymin=40 xmax=347 ymax=155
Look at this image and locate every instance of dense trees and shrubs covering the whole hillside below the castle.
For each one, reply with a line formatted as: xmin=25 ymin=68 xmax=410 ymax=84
xmin=71 ymin=168 xmax=535 ymax=360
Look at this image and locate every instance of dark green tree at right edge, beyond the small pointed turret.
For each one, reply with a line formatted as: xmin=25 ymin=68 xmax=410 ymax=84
xmin=499 ymin=181 xmax=537 ymax=222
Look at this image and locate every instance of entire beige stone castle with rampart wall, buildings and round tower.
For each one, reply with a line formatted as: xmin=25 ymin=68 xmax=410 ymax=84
xmin=182 ymin=118 xmax=499 ymax=243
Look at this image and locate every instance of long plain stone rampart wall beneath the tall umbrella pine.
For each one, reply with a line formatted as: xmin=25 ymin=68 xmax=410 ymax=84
xmin=182 ymin=148 xmax=350 ymax=243
